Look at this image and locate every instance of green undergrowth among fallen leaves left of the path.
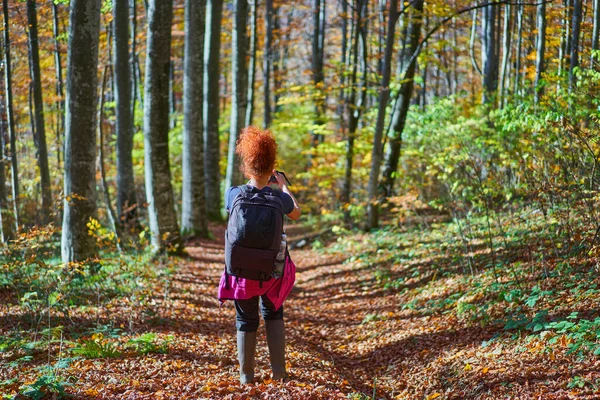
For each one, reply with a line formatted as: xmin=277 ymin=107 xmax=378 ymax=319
xmin=0 ymin=227 xmax=177 ymax=399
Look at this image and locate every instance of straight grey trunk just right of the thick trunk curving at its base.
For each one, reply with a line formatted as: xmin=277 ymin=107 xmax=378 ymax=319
xmin=181 ymin=0 xmax=208 ymax=237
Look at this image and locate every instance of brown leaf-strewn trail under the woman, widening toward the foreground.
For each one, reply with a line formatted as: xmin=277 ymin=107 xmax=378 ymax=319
xmin=62 ymin=228 xmax=592 ymax=400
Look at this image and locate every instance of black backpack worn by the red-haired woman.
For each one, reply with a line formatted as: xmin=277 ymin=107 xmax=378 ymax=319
xmin=225 ymin=185 xmax=283 ymax=281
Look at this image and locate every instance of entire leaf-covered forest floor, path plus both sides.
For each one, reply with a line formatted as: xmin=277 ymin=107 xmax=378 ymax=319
xmin=0 ymin=212 xmax=600 ymax=399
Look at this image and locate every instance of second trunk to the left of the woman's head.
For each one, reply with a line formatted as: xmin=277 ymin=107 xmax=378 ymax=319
xmin=203 ymin=0 xmax=223 ymax=221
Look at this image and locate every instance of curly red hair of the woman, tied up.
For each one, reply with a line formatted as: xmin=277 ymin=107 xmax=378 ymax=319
xmin=235 ymin=126 xmax=277 ymax=178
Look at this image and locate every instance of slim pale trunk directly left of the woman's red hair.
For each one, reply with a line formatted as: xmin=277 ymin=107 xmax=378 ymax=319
xmin=225 ymin=0 xmax=248 ymax=192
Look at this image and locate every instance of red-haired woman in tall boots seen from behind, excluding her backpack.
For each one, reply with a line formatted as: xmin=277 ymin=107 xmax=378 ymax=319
xmin=219 ymin=126 xmax=301 ymax=384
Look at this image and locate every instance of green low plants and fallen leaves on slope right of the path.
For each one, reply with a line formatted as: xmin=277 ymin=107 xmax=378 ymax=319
xmin=322 ymin=200 xmax=600 ymax=358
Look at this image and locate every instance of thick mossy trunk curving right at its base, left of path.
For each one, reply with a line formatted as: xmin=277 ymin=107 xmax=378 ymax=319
xmin=144 ymin=0 xmax=181 ymax=253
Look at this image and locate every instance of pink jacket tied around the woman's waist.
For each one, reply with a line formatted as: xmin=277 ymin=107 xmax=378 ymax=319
xmin=218 ymin=256 xmax=296 ymax=310
